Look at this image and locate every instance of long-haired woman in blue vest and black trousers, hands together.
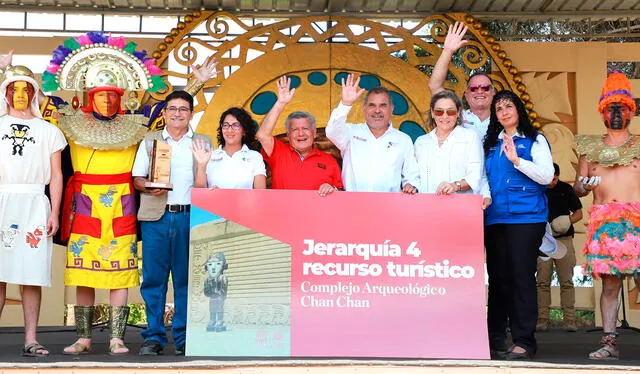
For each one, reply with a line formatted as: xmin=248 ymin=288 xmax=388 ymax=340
xmin=484 ymin=91 xmax=553 ymax=360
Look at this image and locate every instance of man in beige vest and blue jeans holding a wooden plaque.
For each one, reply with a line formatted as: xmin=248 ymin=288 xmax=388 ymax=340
xmin=133 ymin=91 xmax=211 ymax=356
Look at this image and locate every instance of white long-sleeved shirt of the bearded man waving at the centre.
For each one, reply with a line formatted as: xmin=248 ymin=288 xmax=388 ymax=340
xmin=325 ymin=102 xmax=419 ymax=192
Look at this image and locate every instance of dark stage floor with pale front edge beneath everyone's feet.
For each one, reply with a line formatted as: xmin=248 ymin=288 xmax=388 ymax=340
xmin=0 ymin=327 xmax=640 ymax=374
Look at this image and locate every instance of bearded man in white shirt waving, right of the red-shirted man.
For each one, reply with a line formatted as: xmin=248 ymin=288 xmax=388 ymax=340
xmin=325 ymin=74 xmax=419 ymax=194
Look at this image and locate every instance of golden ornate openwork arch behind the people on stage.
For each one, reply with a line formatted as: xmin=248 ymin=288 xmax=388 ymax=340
xmin=152 ymin=11 xmax=539 ymax=140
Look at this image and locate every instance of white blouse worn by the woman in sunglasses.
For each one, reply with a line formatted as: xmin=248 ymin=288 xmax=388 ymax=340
xmin=414 ymin=126 xmax=484 ymax=193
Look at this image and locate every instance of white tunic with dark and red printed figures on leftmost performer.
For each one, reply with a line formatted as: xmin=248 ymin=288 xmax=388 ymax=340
xmin=0 ymin=115 xmax=67 ymax=287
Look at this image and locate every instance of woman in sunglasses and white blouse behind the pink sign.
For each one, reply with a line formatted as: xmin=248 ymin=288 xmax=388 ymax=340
xmin=414 ymin=90 xmax=484 ymax=195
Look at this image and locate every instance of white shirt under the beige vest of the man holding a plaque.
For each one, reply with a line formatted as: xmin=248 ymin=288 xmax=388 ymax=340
xmin=132 ymin=128 xmax=193 ymax=205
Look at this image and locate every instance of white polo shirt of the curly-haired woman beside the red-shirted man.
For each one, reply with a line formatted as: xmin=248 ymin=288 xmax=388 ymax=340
xmin=207 ymin=144 xmax=267 ymax=189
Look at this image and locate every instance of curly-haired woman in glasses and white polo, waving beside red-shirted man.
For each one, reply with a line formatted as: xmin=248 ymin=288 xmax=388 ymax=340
xmin=192 ymin=108 xmax=267 ymax=189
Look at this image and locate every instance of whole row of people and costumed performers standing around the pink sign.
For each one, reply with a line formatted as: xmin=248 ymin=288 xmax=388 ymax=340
xmin=0 ymin=23 xmax=640 ymax=360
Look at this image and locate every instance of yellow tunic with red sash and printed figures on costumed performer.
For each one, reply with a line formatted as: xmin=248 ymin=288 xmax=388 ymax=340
xmin=64 ymin=142 xmax=140 ymax=289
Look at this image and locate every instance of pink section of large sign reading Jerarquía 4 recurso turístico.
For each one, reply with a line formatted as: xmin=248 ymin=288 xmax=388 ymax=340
xmin=192 ymin=189 xmax=489 ymax=359
